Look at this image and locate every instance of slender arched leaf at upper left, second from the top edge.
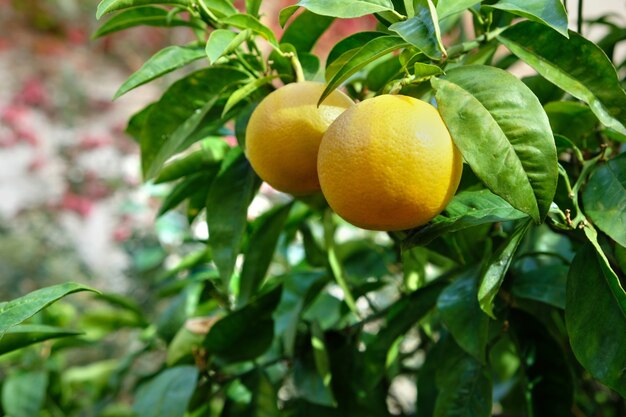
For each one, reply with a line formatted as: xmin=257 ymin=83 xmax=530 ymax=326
xmin=92 ymin=7 xmax=196 ymax=39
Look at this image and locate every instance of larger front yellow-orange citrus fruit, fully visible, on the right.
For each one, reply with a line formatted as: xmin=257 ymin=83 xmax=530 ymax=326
xmin=317 ymin=95 xmax=463 ymax=231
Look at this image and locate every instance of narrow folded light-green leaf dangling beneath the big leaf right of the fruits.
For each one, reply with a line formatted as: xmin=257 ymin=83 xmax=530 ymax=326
xmin=478 ymin=221 xmax=531 ymax=319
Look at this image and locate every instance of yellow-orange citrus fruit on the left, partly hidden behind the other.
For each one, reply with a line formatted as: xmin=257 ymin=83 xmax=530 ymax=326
xmin=246 ymin=81 xmax=354 ymax=195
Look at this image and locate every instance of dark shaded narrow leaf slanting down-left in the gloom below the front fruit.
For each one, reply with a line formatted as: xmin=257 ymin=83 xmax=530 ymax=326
xmin=361 ymin=281 xmax=447 ymax=388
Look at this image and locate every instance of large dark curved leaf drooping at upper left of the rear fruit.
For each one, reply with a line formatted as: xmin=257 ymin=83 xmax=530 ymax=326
xmin=141 ymin=66 xmax=248 ymax=178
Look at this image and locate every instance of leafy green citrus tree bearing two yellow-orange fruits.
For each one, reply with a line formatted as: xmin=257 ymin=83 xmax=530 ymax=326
xmin=0 ymin=0 xmax=626 ymax=417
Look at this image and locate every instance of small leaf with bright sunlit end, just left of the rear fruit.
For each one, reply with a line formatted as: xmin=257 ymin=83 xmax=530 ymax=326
xmin=154 ymin=138 xmax=230 ymax=184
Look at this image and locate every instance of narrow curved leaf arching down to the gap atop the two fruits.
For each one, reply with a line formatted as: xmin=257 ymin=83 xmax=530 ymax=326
xmin=318 ymin=36 xmax=408 ymax=103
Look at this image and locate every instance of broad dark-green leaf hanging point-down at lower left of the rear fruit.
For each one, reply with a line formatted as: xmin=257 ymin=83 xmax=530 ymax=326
xmin=207 ymin=148 xmax=261 ymax=283
